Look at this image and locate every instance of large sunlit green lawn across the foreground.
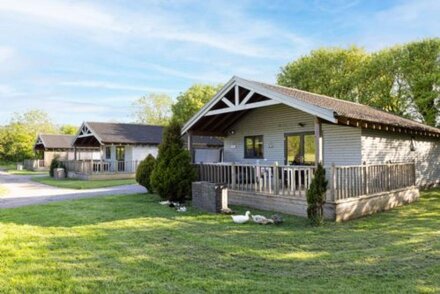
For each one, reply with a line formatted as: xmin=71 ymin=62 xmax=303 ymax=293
xmin=0 ymin=190 xmax=440 ymax=293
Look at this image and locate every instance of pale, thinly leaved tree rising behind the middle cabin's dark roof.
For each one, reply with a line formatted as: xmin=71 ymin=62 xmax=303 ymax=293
xmin=132 ymin=93 xmax=173 ymax=125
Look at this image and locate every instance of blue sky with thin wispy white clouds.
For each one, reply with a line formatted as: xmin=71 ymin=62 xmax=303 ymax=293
xmin=0 ymin=0 xmax=440 ymax=124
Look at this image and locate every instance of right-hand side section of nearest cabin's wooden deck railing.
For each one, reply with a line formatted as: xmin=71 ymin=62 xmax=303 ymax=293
xmin=329 ymin=162 xmax=416 ymax=200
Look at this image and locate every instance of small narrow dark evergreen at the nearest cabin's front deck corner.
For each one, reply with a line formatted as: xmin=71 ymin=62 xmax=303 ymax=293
xmin=307 ymin=164 xmax=328 ymax=225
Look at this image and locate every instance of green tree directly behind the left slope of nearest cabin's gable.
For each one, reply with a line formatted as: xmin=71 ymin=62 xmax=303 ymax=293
xmin=172 ymin=84 xmax=222 ymax=124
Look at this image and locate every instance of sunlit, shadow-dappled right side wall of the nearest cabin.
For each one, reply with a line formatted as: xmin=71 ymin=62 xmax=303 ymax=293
xmin=362 ymin=129 xmax=440 ymax=185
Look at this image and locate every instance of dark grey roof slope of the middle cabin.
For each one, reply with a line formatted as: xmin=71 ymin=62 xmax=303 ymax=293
xmin=84 ymin=122 xmax=163 ymax=145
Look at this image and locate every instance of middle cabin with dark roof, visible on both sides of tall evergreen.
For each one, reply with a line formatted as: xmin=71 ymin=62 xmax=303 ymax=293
xmin=64 ymin=122 xmax=223 ymax=179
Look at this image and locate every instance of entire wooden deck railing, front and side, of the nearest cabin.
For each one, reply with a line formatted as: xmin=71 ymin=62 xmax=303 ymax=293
xmin=195 ymin=162 xmax=416 ymax=201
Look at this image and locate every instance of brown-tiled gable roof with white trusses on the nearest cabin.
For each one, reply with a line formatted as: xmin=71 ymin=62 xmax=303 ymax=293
xmin=182 ymin=76 xmax=440 ymax=136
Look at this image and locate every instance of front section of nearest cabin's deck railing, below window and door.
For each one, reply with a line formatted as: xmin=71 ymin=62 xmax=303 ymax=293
xmin=195 ymin=163 xmax=315 ymax=198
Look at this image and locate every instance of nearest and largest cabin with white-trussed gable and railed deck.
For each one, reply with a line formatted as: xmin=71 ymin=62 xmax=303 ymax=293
xmin=182 ymin=77 xmax=440 ymax=220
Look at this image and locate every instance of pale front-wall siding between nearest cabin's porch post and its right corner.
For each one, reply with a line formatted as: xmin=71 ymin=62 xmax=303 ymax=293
xmin=322 ymin=124 xmax=362 ymax=166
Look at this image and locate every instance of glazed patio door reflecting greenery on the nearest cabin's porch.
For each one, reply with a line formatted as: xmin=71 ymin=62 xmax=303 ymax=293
xmin=284 ymin=133 xmax=316 ymax=165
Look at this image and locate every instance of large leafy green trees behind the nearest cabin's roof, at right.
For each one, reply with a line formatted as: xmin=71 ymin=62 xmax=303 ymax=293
xmin=277 ymin=38 xmax=440 ymax=126
